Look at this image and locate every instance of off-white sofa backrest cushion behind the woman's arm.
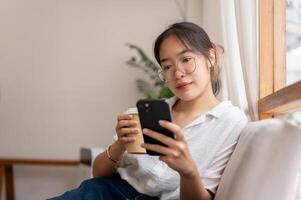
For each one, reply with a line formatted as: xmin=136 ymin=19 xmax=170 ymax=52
xmin=215 ymin=119 xmax=301 ymax=200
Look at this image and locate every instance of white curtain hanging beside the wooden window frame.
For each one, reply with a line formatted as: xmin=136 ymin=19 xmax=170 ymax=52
xmin=220 ymin=0 xmax=259 ymax=120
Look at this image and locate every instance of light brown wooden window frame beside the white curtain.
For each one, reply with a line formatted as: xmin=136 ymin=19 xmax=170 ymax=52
xmin=258 ymin=0 xmax=301 ymax=119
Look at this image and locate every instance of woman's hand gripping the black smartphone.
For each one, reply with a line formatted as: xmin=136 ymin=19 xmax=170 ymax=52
xmin=141 ymin=120 xmax=198 ymax=177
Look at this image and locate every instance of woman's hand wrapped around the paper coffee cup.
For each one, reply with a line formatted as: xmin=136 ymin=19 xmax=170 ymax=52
xmin=115 ymin=114 xmax=139 ymax=150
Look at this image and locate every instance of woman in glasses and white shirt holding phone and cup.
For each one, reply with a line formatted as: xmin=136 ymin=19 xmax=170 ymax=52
xmin=49 ymin=22 xmax=247 ymax=200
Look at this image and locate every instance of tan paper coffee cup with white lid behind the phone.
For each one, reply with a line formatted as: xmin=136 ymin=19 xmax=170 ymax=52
xmin=124 ymin=108 xmax=146 ymax=154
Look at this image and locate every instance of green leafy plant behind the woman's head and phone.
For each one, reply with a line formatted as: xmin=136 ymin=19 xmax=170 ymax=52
xmin=126 ymin=44 xmax=173 ymax=99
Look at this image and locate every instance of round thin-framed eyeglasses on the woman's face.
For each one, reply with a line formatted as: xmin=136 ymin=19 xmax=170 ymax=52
xmin=158 ymin=57 xmax=196 ymax=82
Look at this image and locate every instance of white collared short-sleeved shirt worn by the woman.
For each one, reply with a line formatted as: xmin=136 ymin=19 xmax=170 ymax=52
xmin=117 ymin=97 xmax=248 ymax=200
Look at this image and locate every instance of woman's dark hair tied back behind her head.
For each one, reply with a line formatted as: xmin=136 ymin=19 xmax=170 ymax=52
xmin=154 ymin=22 xmax=220 ymax=95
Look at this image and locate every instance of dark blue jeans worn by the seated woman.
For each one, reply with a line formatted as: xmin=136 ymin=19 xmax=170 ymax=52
xmin=49 ymin=175 xmax=158 ymax=200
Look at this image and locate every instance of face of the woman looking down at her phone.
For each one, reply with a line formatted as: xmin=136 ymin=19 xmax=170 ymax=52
xmin=159 ymin=35 xmax=212 ymax=101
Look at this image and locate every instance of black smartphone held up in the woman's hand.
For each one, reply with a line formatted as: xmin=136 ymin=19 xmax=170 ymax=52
xmin=136 ymin=99 xmax=174 ymax=156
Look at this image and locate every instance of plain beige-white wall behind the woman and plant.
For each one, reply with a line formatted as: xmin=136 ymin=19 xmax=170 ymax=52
xmin=0 ymin=0 xmax=219 ymax=200
